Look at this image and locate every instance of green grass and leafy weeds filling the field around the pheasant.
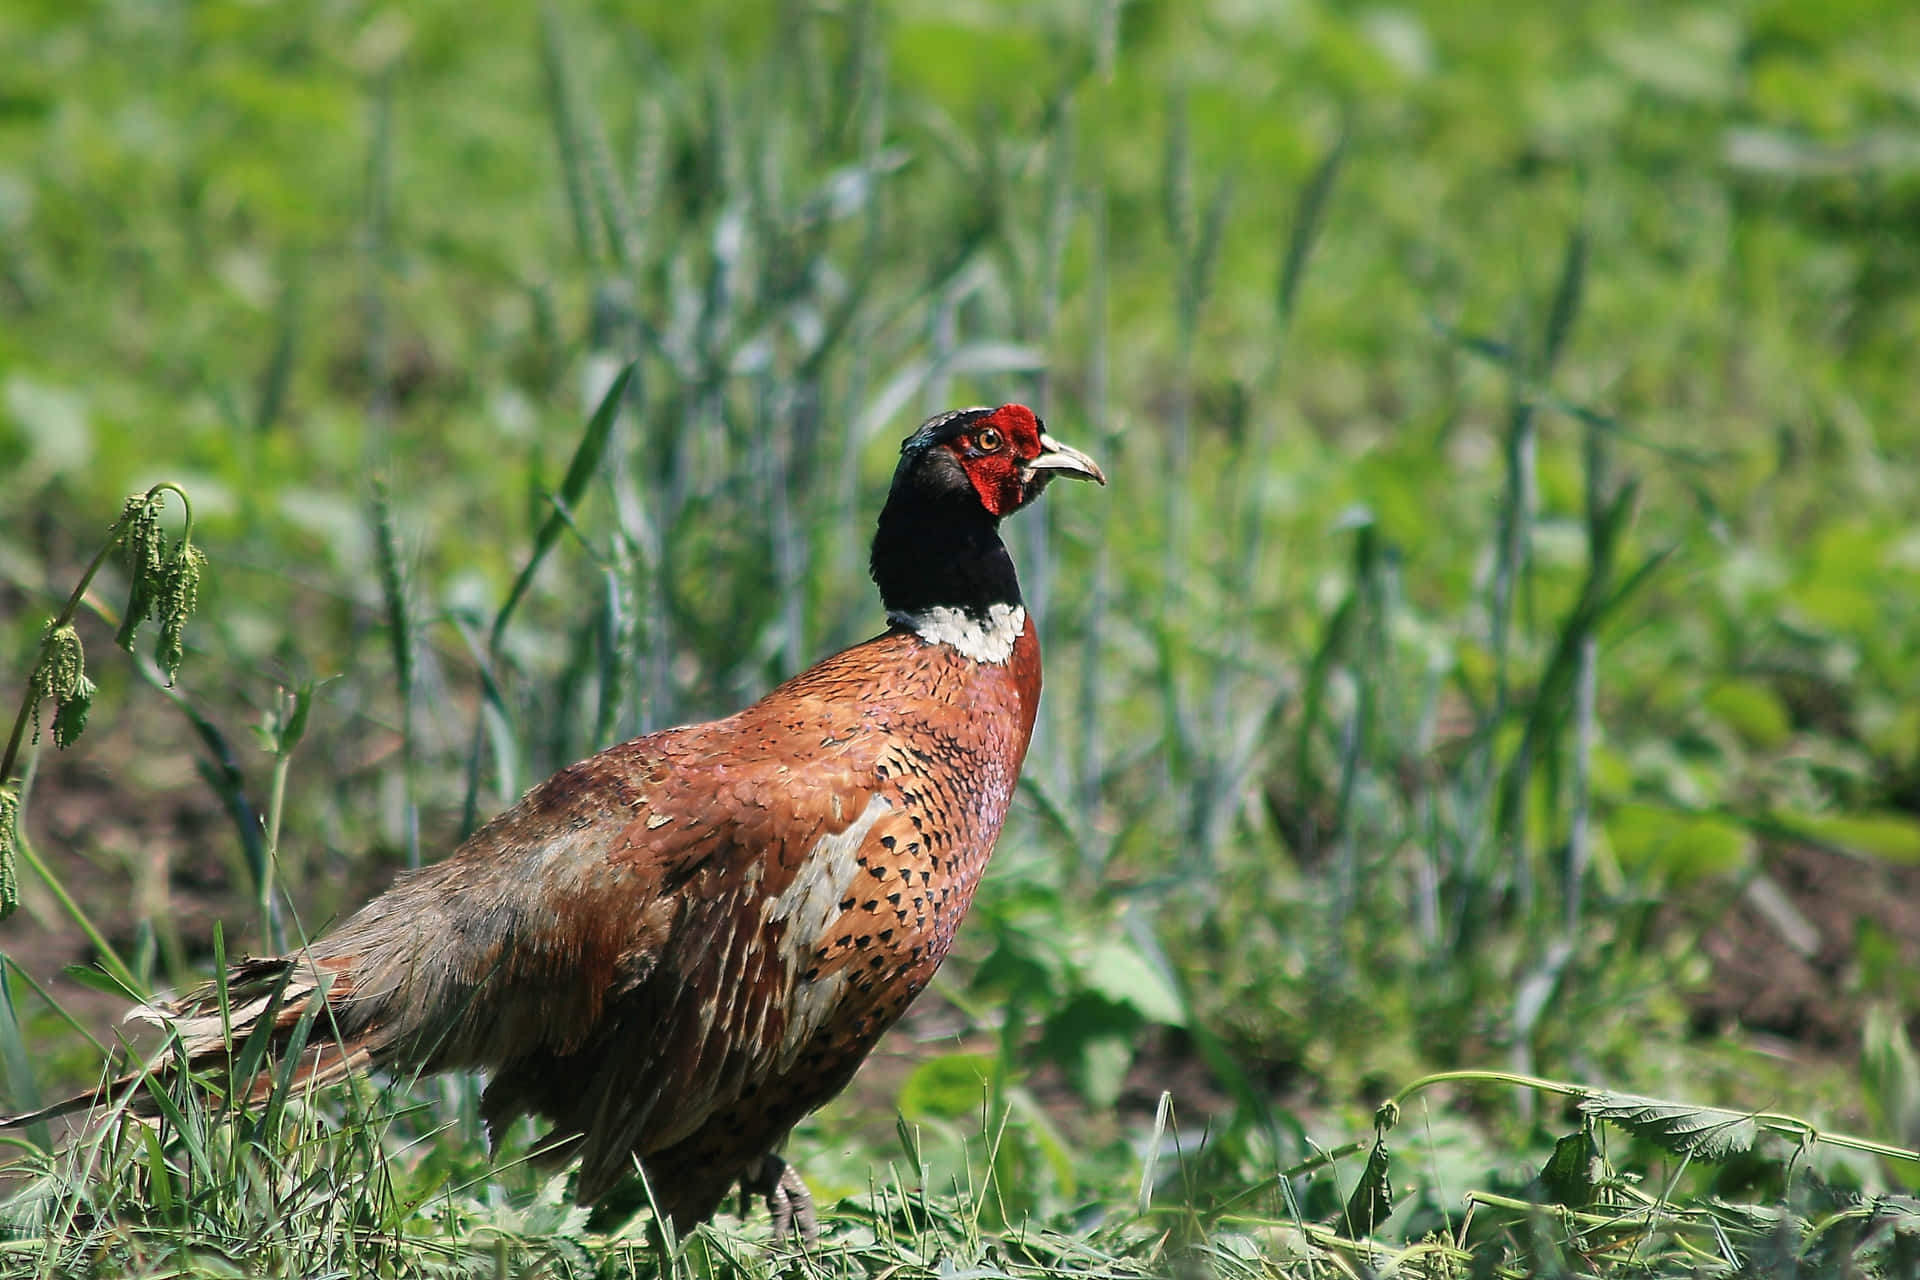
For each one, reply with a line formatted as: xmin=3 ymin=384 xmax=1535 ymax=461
xmin=0 ymin=0 xmax=1920 ymax=1276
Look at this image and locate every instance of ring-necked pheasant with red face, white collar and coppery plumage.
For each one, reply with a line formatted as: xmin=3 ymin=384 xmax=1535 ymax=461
xmin=6 ymin=405 xmax=1106 ymax=1234
